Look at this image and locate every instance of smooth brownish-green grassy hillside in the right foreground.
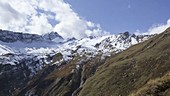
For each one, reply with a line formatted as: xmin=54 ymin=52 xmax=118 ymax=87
xmin=79 ymin=28 xmax=170 ymax=96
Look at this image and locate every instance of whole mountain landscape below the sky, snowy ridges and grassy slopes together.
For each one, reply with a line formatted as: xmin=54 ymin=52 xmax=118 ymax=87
xmin=0 ymin=28 xmax=170 ymax=96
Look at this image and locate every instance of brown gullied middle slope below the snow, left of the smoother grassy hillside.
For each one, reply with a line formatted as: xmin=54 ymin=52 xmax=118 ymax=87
xmin=15 ymin=55 xmax=105 ymax=96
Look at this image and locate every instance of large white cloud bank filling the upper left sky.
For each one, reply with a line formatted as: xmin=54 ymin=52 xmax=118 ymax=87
xmin=0 ymin=0 xmax=107 ymax=38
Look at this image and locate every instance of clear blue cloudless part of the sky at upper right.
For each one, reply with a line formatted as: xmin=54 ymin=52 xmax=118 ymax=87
xmin=65 ymin=0 xmax=170 ymax=33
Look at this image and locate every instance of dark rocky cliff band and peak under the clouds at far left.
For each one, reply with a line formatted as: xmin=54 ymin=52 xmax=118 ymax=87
xmin=0 ymin=30 xmax=63 ymax=43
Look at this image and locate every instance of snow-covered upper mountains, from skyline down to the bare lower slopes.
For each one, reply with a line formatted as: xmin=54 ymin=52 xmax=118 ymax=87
xmin=0 ymin=30 xmax=152 ymax=77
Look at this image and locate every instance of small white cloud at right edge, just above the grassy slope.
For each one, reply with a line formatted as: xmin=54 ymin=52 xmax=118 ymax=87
xmin=135 ymin=19 xmax=170 ymax=35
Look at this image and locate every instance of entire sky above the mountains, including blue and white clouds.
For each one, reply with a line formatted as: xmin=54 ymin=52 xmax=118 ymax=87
xmin=0 ymin=0 xmax=170 ymax=39
